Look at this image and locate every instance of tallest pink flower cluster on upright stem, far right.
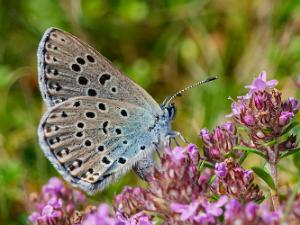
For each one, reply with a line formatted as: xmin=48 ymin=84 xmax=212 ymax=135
xmin=231 ymin=72 xmax=300 ymax=157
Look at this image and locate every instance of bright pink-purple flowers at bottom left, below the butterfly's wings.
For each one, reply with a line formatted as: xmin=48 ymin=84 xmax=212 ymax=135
xmin=29 ymin=177 xmax=153 ymax=225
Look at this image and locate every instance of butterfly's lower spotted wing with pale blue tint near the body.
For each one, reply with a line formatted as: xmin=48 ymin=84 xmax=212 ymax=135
xmin=38 ymin=96 xmax=159 ymax=193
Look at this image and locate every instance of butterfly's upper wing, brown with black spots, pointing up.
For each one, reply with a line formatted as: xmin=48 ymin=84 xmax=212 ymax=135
xmin=38 ymin=28 xmax=160 ymax=113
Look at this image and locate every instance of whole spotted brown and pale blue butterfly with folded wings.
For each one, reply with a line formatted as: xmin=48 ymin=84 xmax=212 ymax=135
xmin=37 ymin=28 xmax=215 ymax=194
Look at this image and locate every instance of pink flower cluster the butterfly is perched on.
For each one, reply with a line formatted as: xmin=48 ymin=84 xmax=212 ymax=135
xmin=115 ymin=145 xmax=212 ymax=224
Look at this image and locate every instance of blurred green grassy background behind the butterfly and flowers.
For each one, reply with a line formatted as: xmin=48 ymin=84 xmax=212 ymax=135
xmin=0 ymin=0 xmax=300 ymax=224
